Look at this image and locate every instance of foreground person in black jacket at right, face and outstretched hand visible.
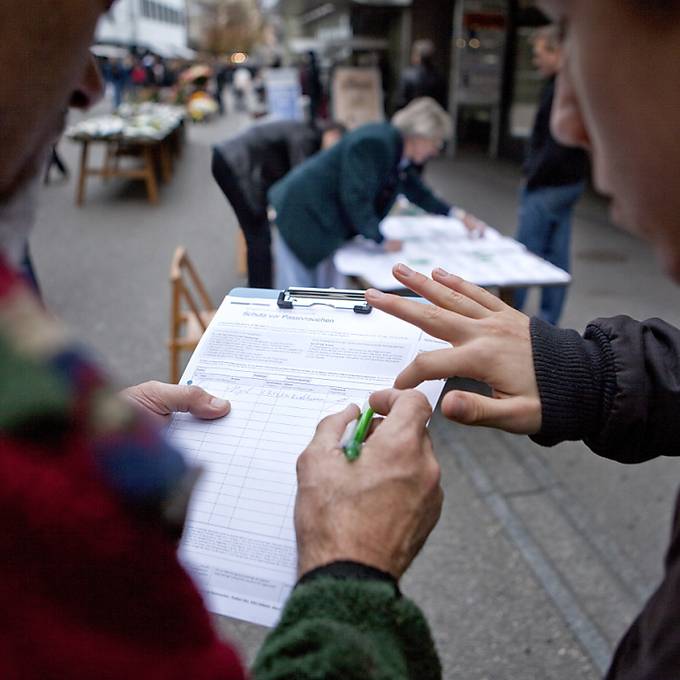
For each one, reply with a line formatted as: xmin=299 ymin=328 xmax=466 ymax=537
xmin=366 ymin=0 xmax=680 ymax=680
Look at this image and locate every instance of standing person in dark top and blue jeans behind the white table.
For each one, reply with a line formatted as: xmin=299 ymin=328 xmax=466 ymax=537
xmin=514 ymin=26 xmax=588 ymax=325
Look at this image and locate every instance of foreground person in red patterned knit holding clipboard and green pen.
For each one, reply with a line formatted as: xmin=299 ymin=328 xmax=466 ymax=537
xmin=0 ymin=0 xmax=442 ymax=680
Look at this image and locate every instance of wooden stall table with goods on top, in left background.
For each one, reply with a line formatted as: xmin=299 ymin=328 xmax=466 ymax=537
xmin=67 ymin=105 xmax=184 ymax=206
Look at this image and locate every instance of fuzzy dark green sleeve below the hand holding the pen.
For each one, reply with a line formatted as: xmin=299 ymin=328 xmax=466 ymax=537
xmin=253 ymin=578 xmax=441 ymax=680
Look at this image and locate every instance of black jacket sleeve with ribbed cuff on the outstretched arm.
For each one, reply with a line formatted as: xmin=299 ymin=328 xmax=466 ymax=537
xmin=531 ymin=316 xmax=680 ymax=463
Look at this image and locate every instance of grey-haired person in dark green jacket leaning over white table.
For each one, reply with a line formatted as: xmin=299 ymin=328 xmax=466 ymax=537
xmin=269 ymin=97 xmax=484 ymax=289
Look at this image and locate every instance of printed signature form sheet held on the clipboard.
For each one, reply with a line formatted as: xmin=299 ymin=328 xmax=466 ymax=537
xmin=169 ymin=297 xmax=447 ymax=625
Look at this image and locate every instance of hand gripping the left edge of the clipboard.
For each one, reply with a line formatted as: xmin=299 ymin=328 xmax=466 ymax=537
xmin=121 ymin=380 xmax=231 ymax=423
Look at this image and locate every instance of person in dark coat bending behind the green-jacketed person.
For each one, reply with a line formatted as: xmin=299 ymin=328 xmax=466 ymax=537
xmin=212 ymin=121 xmax=344 ymax=288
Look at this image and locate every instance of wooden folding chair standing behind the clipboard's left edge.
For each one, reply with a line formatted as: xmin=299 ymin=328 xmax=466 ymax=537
xmin=168 ymin=246 xmax=216 ymax=383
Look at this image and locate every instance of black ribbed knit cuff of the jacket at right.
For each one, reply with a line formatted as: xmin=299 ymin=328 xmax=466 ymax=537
xmin=530 ymin=318 xmax=614 ymax=446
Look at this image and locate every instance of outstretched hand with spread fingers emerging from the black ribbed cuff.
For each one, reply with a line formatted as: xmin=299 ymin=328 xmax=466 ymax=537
xmin=366 ymin=264 xmax=541 ymax=434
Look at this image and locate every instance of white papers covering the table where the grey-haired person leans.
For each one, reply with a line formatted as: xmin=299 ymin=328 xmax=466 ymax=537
xmin=334 ymin=216 xmax=571 ymax=290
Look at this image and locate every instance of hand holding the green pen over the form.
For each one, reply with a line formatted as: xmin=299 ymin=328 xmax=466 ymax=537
xmin=295 ymin=390 xmax=443 ymax=579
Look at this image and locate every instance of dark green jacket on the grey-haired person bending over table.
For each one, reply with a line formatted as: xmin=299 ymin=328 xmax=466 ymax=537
xmin=269 ymin=123 xmax=450 ymax=269
